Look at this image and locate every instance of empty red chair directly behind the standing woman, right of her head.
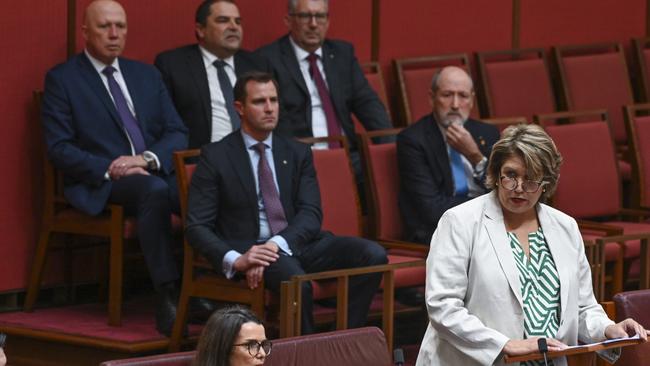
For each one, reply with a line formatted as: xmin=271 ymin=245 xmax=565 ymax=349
xmin=536 ymin=110 xmax=650 ymax=293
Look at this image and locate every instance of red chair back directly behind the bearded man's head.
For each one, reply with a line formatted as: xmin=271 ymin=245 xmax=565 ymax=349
xmin=393 ymin=53 xmax=479 ymax=125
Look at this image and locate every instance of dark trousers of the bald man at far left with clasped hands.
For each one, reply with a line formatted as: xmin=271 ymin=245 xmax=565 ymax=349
xmin=109 ymin=174 xmax=180 ymax=288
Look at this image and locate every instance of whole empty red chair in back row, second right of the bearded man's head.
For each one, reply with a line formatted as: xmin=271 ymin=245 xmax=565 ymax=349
xmin=554 ymin=43 xmax=634 ymax=180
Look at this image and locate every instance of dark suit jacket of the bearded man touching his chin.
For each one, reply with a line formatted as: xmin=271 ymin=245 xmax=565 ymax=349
xmin=397 ymin=114 xmax=499 ymax=244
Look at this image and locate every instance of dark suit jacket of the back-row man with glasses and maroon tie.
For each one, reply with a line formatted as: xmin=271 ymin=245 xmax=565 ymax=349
xmin=257 ymin=35 xmax=392 ymax=149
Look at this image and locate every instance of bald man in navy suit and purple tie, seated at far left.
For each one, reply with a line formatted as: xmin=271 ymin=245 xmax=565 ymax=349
xmin=42 ymin=0 xmax=187 ymax=334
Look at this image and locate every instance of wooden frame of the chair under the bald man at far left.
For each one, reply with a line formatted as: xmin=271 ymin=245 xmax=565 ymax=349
xmin=24 ymin=91 xmax=125 ymax=326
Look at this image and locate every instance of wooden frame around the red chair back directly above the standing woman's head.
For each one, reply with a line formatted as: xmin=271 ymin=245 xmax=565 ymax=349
xmin=476 ymin=48 xmax=558 ymax=118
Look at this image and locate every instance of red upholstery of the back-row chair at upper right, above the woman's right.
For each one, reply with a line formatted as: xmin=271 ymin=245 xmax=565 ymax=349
xmin=562 ymin=53 xmax=634 ymax=143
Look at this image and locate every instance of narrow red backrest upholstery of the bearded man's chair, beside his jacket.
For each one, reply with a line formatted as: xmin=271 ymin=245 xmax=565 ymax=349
xmin=368 ymin=143 xmax=402 ymax=240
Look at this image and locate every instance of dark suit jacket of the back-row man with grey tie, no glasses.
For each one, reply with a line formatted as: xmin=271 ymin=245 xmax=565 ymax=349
xmin=154 ymin=44 xmax=271 ymax=149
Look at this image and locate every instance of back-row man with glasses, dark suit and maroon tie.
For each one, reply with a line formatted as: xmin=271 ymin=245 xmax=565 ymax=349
xmin=258 ymin=0 xmax=392 ymax=179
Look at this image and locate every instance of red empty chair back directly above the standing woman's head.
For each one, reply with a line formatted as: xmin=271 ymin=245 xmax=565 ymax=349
xmin=476 ymin=48 xmax=557 ymax=120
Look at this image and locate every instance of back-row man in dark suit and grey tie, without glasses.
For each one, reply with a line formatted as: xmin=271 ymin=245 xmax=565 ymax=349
xmin=155 ymin=0 xmax=269 ymax=149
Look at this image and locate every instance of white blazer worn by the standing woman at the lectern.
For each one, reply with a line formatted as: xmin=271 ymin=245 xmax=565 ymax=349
xmin=416 ymin=191 xmax=619 ymax=366
